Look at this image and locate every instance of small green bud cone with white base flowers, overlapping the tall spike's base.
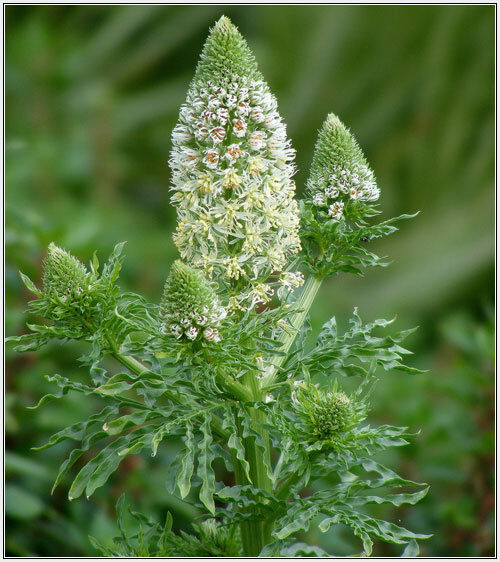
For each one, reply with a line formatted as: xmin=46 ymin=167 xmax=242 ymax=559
xmin=160 ymin=260 xmax=226 ymax=341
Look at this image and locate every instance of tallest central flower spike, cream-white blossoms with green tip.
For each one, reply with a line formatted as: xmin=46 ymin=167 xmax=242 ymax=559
xmin=170 ymin=17 xmax=303 ymax=308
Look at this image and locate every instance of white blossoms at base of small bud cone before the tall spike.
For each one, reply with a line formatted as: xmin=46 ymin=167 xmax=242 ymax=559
xmin=160 ymin=299 xmax=227 ymax=342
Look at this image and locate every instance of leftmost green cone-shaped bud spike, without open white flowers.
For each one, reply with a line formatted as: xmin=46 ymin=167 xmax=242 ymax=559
xmin=43 ymin=242 xmax=89 ymax=302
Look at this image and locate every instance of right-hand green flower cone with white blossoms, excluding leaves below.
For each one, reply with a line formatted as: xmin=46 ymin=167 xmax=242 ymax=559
xmin=307 ymin=114 xmax=380 ymax=221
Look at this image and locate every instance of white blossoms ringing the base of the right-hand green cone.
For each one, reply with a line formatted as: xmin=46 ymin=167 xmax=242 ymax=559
xmin=312 ymin=164 xmax=380 ymax=221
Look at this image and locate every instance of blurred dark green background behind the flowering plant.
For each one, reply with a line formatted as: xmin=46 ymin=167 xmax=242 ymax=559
xmin=5 ymin=5 xmax=495 ymax=557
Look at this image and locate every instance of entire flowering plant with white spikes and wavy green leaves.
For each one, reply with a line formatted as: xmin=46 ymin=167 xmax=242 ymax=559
xmin=10 ymin=17 xmax=429 ymax=557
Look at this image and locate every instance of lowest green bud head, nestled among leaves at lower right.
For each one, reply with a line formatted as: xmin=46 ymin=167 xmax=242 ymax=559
xmin=293 ymin=383 xmax=354 ymax=444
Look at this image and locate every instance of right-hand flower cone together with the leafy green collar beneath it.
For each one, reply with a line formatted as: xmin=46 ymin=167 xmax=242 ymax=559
xmin=300 ymin=113 xmax=388 ymax=278
